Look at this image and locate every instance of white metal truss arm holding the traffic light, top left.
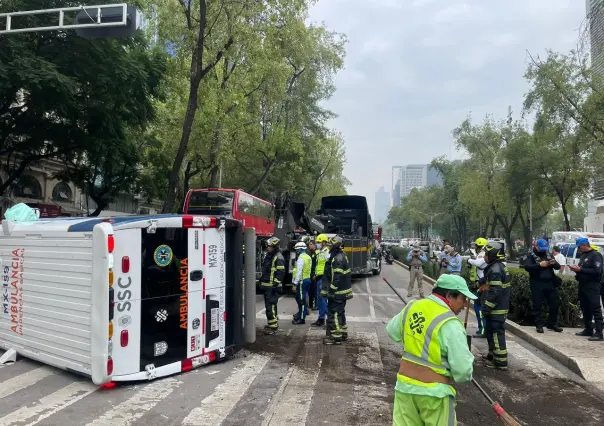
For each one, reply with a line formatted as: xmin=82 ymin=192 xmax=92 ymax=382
xmin=0 ymin=3 xmax=128 ymax=34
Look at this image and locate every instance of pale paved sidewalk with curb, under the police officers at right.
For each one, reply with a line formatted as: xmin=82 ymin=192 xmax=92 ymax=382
xmin=395 ymin=261 xmax=604 ymax=391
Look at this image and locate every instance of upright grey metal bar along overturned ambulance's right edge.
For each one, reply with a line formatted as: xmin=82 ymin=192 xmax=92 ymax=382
xmin=243 ymin=228 xmax=256 ymax=343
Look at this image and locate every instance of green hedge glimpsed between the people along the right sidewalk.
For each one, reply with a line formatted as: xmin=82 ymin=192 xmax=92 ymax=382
xmin=392 ymin=247 xmax=581 ymax=327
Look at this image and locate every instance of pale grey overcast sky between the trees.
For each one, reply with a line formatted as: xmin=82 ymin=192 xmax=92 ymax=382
xmin=311 ymin=0 xmax=585 ymax=218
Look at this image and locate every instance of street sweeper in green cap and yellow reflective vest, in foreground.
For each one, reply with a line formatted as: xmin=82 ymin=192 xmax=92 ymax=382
xmin=386 ymin=274 xmax=476 ymax=426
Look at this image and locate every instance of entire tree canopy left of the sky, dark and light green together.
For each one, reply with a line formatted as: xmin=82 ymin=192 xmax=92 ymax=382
xmin=0 ymin=0 xmax=350 ymax=214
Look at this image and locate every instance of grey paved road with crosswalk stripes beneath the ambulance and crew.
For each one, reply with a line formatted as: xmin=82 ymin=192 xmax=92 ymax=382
xmin=0 ymin=266 xmax=604 ymax=426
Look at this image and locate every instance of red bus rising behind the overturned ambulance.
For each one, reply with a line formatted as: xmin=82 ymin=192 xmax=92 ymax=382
xmin=183 ymin=188 xmax=275 ymax=237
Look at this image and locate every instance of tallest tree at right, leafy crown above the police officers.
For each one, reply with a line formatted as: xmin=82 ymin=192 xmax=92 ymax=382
xmin=524 ymin=52 xmax=603 ymax=229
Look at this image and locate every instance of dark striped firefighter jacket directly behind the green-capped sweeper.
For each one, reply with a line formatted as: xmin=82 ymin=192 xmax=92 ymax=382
xmin=481 ymin=260 xmax=512 ymax=320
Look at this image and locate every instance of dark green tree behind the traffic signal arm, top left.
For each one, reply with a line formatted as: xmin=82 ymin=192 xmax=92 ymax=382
xmin=0 ymin=0 xmax=165 ymax=202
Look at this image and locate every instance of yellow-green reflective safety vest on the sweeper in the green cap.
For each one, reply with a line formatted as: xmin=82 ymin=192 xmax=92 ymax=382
xmin=401 ymin=299 xmax=463 ymax=392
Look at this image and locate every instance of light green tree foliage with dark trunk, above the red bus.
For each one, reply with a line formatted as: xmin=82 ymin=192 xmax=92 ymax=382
xmin=140 ymin=0 xmax=349 ymax=210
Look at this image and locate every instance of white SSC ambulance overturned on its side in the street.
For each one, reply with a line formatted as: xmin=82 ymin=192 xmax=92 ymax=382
xmin=0 ymin=215 xmax=243 ymax=385
